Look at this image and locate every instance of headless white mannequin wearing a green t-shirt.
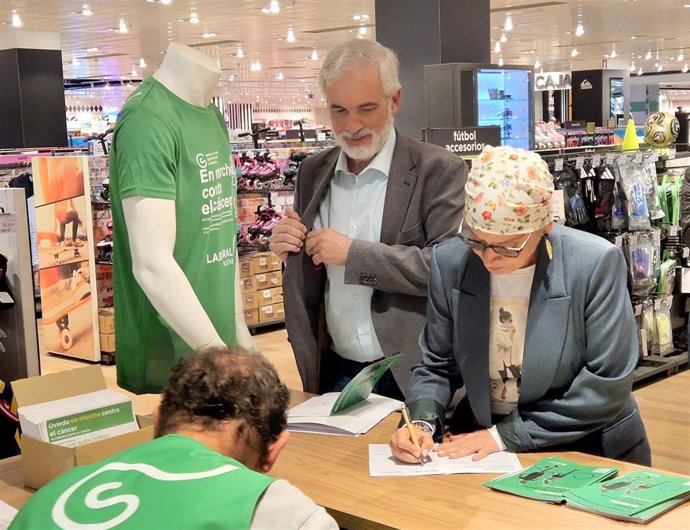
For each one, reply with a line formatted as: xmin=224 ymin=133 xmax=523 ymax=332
xmin=110 ymin=43 xmax=257 ymax=393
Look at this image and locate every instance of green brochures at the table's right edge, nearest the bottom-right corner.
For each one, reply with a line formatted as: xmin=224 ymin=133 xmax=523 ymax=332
xmin=565 ymin=471 xmax=690 ymax=523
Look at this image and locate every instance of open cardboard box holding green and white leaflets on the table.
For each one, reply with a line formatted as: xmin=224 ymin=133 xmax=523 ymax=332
xmin=12 ymin=366 xmax=153 ymax=489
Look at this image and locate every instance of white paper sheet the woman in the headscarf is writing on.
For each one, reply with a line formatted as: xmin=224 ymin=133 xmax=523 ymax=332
xmin=369 ymin=444 xmax=522 ymax=477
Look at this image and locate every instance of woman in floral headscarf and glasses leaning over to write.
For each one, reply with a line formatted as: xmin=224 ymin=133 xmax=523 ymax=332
xmin=390 ymin=147 xmax=651 ymax=465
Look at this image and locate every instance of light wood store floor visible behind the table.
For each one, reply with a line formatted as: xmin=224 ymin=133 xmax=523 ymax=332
xmin=39 ymin=329 xmax=690 ymax=475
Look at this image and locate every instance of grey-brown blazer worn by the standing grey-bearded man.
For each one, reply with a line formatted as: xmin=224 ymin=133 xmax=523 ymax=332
xmin=283 ymin=133 xmax=467 ymax=393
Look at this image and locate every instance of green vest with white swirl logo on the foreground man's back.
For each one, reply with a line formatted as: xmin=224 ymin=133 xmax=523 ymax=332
xmin=10 ymin=434 xmax=275 ymax=530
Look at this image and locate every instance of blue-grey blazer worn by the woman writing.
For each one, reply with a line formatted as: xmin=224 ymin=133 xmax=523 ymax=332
xmin=407 ymin=225 xmax=651 ymax=465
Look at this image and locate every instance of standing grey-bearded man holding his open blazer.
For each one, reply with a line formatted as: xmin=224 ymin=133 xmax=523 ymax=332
xmin=271 ymin=39 xmax=467 ymax=399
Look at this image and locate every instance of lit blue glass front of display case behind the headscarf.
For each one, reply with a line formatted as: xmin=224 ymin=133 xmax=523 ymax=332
xmin=477 ymin=69 xmax=532 ymax=149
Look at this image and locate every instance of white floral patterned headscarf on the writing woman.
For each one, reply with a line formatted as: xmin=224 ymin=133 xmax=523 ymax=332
xmin=465 ymin=146 xmax=553 ymax=235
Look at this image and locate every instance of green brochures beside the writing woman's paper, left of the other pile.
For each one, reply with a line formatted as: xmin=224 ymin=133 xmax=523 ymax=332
xmin=484 ymin=456 xmax=618 ymax=504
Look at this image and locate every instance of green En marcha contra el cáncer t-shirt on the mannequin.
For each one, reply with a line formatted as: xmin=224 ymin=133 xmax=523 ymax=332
xmin=110 ymin=77 xmax=237 ymax=393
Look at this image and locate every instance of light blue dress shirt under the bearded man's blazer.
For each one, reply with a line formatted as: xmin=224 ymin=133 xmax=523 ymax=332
xmin=314 ymin=128 xmax=396 ymax=362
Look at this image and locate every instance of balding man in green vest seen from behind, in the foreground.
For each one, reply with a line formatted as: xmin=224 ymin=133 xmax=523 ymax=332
xmin=10 ymin=348 xmax=338 ymax=530
